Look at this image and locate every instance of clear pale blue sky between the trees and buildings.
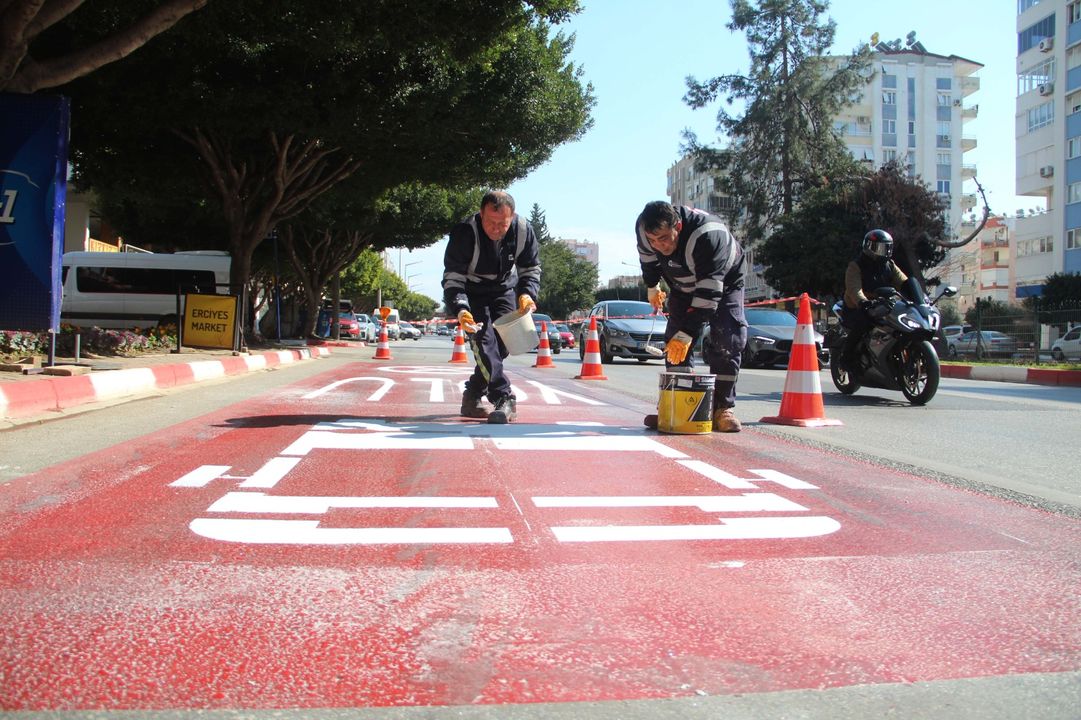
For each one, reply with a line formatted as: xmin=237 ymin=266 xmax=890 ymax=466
xmin=402 ymin=0 xmax=1024 ymax=302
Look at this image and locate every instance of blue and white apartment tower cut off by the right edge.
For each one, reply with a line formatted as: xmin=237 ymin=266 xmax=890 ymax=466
xmin=1014 ymin=0 xmax=1081 ymax=298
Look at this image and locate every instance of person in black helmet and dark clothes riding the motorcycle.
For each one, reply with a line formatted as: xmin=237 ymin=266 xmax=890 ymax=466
xmin=840 ymin=228 xmax=922 ymax=372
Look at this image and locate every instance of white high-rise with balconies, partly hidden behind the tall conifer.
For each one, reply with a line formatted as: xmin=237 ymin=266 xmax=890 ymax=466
xmin=668 ymin=32 xmax=984 ymax=301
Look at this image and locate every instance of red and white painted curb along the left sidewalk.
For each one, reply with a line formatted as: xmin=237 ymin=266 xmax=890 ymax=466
xmin=0 ymin=346 xmax=331 ymax=419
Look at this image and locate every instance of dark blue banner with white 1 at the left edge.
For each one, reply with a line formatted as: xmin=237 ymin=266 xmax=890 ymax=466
xmin=0 ymin=94 xmax=71 ymax=331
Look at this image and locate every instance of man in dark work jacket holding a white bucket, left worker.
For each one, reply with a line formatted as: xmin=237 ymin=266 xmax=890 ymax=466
xmin=443 ymin=190 xmax=541 ymax=424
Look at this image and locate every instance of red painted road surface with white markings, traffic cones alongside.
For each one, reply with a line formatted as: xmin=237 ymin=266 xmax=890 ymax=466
xmin=0 ymin=362 xmax=1081 ymax=710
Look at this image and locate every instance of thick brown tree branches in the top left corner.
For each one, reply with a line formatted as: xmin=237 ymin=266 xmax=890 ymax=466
xmin=0 ymin=0 xmax=208 ymax=94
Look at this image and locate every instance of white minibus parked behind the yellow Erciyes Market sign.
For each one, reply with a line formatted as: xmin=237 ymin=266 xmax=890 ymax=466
xmin=61 ymin=251 xmax=231 ymax=329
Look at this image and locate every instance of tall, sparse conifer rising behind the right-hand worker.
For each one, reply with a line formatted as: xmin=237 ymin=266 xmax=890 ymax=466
xmin=684 ymin=0 xmax=870 ymax=240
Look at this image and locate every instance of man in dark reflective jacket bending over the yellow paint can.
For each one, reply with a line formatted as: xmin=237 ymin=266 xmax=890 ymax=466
xmin=635 ymin=201 xmax=747 ymax=432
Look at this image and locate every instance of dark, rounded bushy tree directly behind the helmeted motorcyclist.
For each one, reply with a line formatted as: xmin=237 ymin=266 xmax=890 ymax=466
xmin=756 ymin=163 xmax=946 ymax=297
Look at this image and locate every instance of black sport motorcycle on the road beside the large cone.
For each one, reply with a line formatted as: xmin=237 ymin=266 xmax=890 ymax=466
xmin=827 ymin=286 xmax=957 ymax=405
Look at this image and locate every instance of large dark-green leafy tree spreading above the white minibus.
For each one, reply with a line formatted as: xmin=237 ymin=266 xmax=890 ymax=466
xmin=66 ymin=0 xmax=592 ymax=304
